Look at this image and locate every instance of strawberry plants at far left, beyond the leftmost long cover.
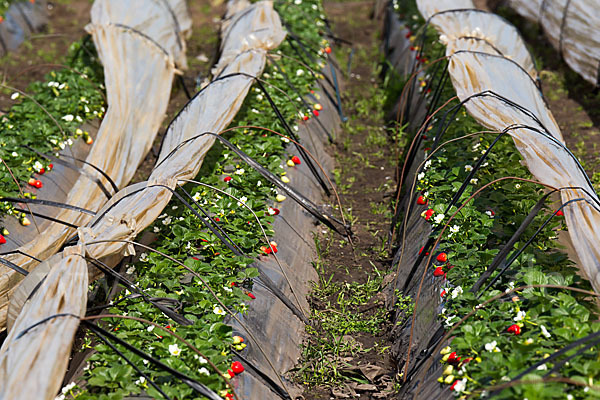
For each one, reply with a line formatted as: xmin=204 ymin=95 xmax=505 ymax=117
xmin=0 ymin=40 xmax=106 ymax=227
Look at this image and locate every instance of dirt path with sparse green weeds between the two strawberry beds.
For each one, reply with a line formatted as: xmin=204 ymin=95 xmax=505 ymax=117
xmin=298 ymin=1 xmax=395 ymax=400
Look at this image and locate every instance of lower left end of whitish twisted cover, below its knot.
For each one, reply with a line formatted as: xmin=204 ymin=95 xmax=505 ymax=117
xmin=0 ymin=245 xmax=88 ymax=400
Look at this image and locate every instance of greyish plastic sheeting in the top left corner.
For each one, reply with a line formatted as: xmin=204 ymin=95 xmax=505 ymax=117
xmin=0 ymin=0 xmax=48 ymax=57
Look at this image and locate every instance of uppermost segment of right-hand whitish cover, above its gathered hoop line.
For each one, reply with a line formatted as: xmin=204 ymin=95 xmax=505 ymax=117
xmin=429 ymin=10 xmax=538 ymax=79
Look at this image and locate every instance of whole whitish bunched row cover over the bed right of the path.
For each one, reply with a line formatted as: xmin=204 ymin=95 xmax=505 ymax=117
xmin=418 ymin=0 xmax=600 ymax=291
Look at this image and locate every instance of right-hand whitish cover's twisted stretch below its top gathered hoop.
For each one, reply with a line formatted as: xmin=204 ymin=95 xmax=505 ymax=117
xmin=448 ymin=52 xmax=600 ymax=291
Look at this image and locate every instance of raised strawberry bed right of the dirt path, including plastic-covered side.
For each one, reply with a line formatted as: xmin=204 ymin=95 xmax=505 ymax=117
xmin=388 ymin=2 xmax=600 ymax=399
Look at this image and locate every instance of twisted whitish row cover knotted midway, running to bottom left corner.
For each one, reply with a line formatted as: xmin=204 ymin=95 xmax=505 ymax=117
xmin=0 ymin=1 xmax=285 ymax=400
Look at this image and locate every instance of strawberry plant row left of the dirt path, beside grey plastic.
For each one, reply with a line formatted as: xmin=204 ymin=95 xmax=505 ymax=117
xmin=67 ymin=1 xmax=338 ymax=399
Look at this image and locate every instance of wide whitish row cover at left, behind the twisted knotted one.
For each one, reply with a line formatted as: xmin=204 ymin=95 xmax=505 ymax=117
xmin=0 ymin=0 xmax=189 ymax=330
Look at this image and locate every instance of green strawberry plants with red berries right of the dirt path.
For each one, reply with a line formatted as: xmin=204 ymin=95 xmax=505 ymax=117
xmin=394 ymin=1 xmax=600 ymax=400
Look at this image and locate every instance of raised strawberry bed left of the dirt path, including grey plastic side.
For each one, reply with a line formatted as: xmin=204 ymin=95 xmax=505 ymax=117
xmin=17 ymin=1 xmax=345 ymax=399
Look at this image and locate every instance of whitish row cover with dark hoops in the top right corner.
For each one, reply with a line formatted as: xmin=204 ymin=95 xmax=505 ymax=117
xmin=508 ymin=0 xmax=600 ymax=85
